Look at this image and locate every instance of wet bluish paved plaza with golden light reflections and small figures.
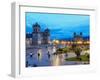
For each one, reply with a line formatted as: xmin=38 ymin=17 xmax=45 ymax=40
xmin=26 ymin=46 xmax=89 ymax=67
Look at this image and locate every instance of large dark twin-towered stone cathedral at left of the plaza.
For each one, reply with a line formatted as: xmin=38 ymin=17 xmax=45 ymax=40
xmin=32 ymin=23 xmax=50 ymax=45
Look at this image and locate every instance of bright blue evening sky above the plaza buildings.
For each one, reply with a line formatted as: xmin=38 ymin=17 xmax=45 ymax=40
xmin=25 ymin=12 xmax=90 ymax=39
